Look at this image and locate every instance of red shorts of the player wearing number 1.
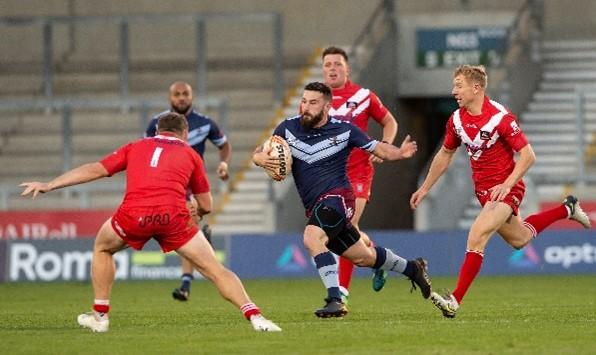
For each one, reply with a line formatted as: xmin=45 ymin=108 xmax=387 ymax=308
xmin=112 ymin=206 xmax=199 ymax=253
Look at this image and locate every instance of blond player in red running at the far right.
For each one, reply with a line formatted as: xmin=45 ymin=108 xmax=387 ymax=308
xmin=410 ymin=65 xmax=591 ymax=318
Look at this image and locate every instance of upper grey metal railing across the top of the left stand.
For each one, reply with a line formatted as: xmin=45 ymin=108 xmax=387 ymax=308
xmin=0 ymin=13 xmax=284 ymax=107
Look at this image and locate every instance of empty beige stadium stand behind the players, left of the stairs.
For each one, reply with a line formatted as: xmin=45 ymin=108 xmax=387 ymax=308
xmin=0 ymin=0 xmax=377 ymax=235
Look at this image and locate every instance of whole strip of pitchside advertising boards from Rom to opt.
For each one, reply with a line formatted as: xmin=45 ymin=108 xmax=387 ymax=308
xmin=0 ymin=230 xmax=596 ymax=282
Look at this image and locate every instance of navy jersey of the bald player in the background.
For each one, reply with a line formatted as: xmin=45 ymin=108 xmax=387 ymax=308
xmin=145 ymin=110 xmax=228 ymax=157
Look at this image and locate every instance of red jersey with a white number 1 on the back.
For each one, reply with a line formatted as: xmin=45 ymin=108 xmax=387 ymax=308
xmin=101 ymin=134 xmax=209 ymax=208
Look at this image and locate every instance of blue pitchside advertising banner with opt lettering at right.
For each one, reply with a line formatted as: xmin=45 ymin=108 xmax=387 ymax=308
xmin=228 ymin=230 xmax=596 ymax=278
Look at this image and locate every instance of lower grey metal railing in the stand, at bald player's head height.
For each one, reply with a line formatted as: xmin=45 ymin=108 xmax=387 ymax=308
xmin=0 ymin=97 xmax=228 ymax=210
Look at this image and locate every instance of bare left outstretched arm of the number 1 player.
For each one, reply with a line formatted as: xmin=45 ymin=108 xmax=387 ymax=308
xmin=19 ymin=162 xmax=108 ymax=198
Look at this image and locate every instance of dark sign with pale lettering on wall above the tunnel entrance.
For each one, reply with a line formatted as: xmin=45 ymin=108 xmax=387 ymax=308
xmin=416 ymin=26 xmax=507 ymax=69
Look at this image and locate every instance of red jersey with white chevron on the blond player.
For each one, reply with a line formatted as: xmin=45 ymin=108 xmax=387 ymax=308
xmin=443 ymin=96 xmax=528 ymax=190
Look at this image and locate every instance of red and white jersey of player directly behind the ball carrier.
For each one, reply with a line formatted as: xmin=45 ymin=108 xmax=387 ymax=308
xmin=329 ymin=80 xmax=387 ymax=170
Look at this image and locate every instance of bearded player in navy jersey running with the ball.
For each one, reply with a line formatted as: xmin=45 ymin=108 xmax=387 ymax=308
xmin=253 ymin=82 xmax=431 ymax=318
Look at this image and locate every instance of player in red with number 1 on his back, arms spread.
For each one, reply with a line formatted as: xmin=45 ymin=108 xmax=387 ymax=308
xmin=20 ymin=113 xmax=281 ymax=332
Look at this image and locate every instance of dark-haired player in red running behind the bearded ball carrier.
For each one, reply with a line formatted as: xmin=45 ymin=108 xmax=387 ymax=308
xmin=322 ymin=46 xmax=397 ymax=303
